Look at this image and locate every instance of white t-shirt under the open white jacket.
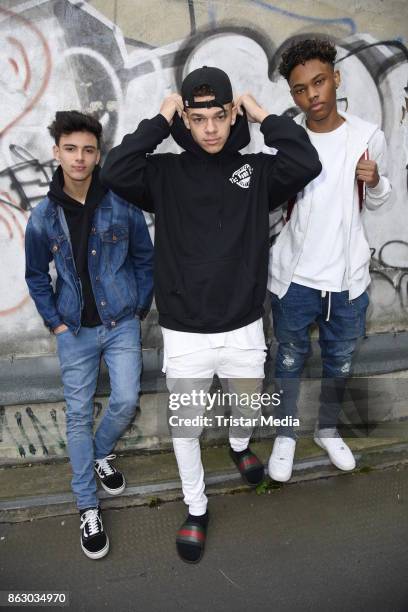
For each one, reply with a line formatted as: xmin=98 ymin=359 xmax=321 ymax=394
xmin=292 ymin=122 xmax=347 ymax=291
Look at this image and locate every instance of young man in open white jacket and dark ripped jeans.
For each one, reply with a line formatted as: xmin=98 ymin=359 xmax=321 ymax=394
xmin=268 ymin=39 xmax=391 ymax=482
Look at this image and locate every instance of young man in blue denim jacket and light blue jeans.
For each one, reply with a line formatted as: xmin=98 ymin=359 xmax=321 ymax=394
xmin=26 ymin=111 xmax=153 ymax=559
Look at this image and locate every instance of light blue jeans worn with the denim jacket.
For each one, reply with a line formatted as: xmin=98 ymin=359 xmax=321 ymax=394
xmin=57 ymin=318 xmax=142 ymax=510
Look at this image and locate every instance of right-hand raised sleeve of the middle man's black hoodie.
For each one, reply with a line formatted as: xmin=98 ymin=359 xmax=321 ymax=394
xmin=261 ymin=115 xmax=322 ymax=210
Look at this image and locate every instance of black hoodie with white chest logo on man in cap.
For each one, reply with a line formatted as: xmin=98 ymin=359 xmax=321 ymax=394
xmin=101 ymin=114 xmax=321 ymax=333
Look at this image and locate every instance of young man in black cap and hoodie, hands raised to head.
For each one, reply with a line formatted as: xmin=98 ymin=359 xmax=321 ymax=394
xmin=102 ymin=66 xmax=321 ymax=563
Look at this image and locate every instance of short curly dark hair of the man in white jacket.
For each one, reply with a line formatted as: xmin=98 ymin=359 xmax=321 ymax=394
xmin=279 ymin=38 xmax=337 ymax=81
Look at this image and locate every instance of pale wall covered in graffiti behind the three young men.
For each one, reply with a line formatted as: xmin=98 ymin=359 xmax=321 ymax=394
xmin=0 ymin=0 xmax=408 ymax=356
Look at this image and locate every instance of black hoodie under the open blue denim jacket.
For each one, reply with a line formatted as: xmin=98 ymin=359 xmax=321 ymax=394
xmin=47 ymin=166 xmax=107 ymax=327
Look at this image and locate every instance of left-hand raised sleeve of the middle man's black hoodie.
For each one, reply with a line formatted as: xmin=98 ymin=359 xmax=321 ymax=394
xmin=100 ymin=114 xmax=170 ymax=212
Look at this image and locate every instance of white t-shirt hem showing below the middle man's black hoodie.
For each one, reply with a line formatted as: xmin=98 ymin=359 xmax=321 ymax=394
xmin=161 ymin=317 xmax=266 ymax=372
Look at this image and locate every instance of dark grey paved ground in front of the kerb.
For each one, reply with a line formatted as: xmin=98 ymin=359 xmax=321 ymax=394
xmin=0 ymin=468 xmax=408 ymax=612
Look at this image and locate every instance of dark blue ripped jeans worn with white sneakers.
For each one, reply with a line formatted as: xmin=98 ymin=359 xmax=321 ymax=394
xmin=271 ymin=283 xmax=368 ymax=438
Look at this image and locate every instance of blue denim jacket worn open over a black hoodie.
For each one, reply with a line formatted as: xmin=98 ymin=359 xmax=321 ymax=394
xmin=25 ymin=191 xmax=153 ymax=333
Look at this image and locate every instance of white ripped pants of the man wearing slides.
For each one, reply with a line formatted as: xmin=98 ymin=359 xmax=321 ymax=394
xmin=166 ymin=347 xmax=266 ymax=516
